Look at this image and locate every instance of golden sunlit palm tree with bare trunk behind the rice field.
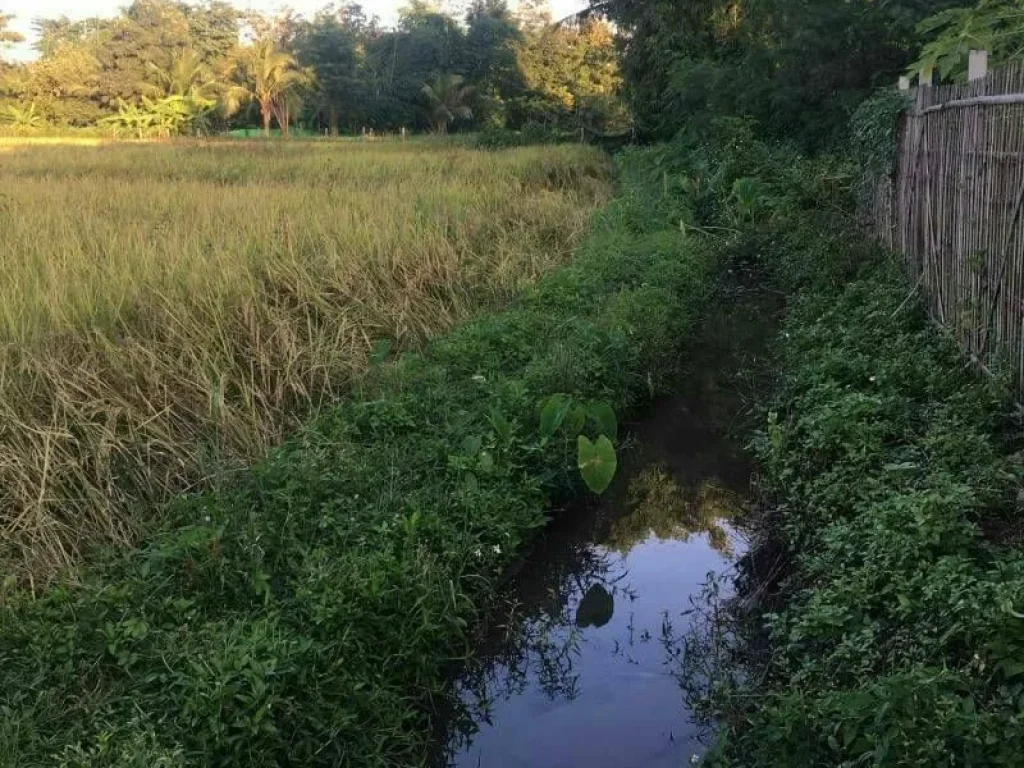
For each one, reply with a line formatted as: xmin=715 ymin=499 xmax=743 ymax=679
xmin=230 ymin=40 xmax=313 ymax=136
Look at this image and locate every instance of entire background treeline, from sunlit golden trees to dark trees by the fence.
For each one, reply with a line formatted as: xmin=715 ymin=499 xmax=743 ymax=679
xmin=0 ymin=0 xmax=1024 ymax=150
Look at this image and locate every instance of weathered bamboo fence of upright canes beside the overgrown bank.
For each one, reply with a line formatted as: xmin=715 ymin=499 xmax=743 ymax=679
xmin=866 ymin=62 xmax=1024 ymax=396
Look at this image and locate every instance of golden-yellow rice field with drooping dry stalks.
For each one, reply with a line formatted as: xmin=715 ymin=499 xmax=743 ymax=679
xmin=0 ymin=142 xmax=608 ymax=577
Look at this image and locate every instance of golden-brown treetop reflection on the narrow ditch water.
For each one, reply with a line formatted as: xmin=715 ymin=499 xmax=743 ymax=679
xmin=608 ymin=467 xmax=741 ymax=555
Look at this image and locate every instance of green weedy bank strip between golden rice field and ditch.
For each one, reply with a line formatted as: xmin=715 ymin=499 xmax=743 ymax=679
xmin=0 ymin=147 xmax=709 ymax=766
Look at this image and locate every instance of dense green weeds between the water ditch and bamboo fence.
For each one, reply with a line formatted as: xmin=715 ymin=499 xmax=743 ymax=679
xmin=655 ymin=129 xmax=1024 ymax=767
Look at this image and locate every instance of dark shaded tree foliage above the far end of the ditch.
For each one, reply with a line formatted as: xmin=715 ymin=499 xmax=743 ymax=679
xmin=592 ymin=0 xmax=955 ymax=150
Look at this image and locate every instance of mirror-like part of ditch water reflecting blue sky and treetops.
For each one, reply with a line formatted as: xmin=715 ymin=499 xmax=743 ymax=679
xmin=449 ymin=464 xmax=741 ymax=768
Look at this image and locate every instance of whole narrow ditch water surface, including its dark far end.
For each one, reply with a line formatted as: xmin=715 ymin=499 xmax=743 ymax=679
xmin=447 ymin=282 xmax=770 ymax=768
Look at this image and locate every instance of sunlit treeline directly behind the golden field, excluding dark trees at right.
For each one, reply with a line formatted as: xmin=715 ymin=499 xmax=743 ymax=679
xmin=0 ymin=0 xmax=628 ymax=135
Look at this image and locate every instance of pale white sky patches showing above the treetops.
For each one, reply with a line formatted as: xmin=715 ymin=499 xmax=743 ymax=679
xmin=0 ymin=0 xmax=587 ymax=60
